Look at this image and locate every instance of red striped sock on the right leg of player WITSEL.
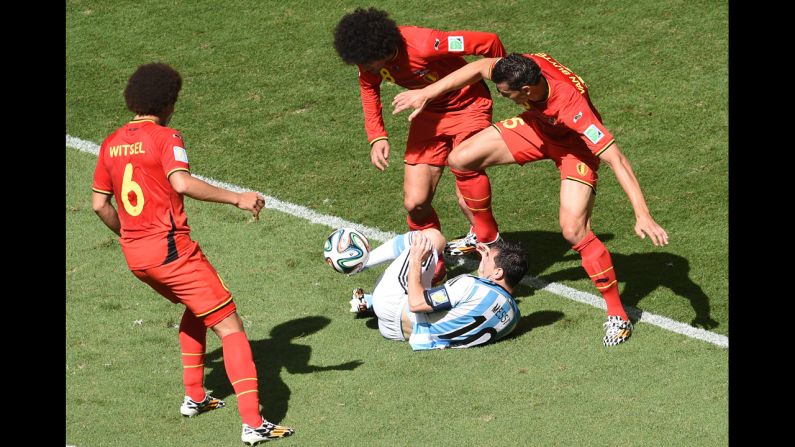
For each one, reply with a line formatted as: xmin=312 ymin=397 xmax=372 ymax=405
xmin=221 ymin=332 xmax=262 ymax=427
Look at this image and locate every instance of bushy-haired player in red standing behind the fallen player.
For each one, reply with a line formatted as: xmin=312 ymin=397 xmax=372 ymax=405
xmin=334 ymin=8 xmax=505 ymax=284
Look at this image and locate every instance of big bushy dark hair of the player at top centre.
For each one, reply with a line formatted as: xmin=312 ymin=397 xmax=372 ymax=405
xmin=334 ymin=8 xmax=403 ymax=65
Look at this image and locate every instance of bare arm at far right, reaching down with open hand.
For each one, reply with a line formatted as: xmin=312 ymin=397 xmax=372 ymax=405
xmin=599 ymin=143 xmax=668 ymax=246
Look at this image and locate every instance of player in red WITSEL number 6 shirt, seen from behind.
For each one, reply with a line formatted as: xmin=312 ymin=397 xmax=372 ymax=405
xmin=92 ymin=63 xmax=293 ymax=445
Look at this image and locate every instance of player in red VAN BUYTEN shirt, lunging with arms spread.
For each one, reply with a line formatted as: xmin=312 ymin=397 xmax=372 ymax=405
xmin=392 ymin=53 xmax=668 ymax=346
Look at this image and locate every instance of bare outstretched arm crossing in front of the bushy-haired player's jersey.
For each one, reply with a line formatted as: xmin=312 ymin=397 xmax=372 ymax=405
xmin=392 ymin=57 xmax=499 ymax=121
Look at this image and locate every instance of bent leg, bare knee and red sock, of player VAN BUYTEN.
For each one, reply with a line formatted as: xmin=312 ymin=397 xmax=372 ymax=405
xmin=447 ymin=126 xmax=515 ymax=247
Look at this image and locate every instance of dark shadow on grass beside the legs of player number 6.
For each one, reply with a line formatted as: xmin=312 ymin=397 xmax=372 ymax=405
xmin=204 ymin=316 xmax=362 ymax=423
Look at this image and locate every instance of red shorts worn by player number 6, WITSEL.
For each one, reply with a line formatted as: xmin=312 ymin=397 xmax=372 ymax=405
xmin=132 ymin=241 xmax=236 ymax=327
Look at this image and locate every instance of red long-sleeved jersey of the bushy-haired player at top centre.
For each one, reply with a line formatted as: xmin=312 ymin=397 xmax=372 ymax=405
xmin=359 ymin=26 xmax=505 ymax=143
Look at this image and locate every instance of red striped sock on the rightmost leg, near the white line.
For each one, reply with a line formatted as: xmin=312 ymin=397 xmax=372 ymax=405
xmin=572 ymin=231 xmax=629 ymax=321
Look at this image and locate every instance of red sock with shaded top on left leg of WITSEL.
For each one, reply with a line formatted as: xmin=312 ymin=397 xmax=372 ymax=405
xmin=179 ymin=309 xmax=207 ymax=402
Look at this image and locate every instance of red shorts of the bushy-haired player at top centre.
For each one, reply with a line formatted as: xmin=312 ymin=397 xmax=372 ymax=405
xmin=403 ymin=98 xmax=492 ymax=166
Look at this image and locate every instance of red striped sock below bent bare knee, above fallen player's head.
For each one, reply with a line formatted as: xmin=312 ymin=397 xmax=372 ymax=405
xmin=450 ymin=168 xmax=499 ymax=243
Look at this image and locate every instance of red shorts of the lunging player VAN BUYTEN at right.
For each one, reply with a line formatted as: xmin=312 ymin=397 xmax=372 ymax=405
xmin=493 ymin=117 xmax=600 ymax=193
